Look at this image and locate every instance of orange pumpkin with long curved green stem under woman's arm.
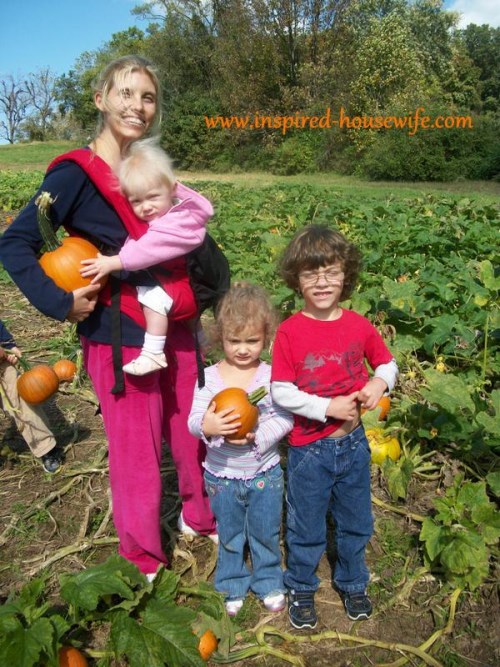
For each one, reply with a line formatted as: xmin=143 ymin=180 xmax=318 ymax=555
xmin=35 ymin=192 xmax=106 ymax=292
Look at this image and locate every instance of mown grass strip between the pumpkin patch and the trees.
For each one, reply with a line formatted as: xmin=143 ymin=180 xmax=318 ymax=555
xmin=0 ymin=141 xmax=500 ymax=204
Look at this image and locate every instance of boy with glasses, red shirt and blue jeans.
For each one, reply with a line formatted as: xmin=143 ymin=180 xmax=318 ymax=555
xmin=271 ymin=225 xmax=398 ymax=628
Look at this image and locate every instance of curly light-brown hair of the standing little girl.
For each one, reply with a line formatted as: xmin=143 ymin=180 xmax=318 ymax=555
xmin=212 ymin=282 xmax=278 ymax=347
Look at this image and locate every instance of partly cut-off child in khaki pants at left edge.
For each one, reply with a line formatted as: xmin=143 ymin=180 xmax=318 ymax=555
xmin=0 ymin=320 xmax=62 ymax=473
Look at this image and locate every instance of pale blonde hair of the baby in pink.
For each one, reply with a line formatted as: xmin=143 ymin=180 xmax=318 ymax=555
xmin=118 ymin=137 xmax=175 ymax=197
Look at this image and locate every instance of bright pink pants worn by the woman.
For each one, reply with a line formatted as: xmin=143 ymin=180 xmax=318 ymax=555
xmin=82 ymin=323 xmax=215 ymax=573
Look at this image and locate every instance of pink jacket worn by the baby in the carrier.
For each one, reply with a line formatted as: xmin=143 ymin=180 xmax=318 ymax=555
xmin=119 ymin=183 xmax=213 ymax=271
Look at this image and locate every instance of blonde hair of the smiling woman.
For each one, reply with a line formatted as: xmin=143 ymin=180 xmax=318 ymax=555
xmin=92 ymin=55 xmax=162 ymax=136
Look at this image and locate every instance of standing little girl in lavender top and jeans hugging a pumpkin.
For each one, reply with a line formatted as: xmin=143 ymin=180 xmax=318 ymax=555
xmin=188 ymin=283 xmax=292 ymax=615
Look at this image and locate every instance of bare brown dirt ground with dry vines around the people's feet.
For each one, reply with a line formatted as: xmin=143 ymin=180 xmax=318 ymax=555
xmin=0 ymin=228 xmax=500 ymax=667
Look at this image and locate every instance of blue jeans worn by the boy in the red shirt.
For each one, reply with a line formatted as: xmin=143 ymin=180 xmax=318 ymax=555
xmin=284 ymin=425 xmax=373 ymax=593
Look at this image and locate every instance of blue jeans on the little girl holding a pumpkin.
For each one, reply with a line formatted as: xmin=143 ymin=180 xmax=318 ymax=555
xmin=205 ymin=465 xmax=285 ymax=600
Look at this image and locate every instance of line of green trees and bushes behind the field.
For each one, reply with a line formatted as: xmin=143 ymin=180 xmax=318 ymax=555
xmin=0 ymin=0 xmax=500 ymax=180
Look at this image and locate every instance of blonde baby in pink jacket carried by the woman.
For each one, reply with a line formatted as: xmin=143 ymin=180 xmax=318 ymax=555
xmin=81 ymin=139 xmax=212 ymax=375
